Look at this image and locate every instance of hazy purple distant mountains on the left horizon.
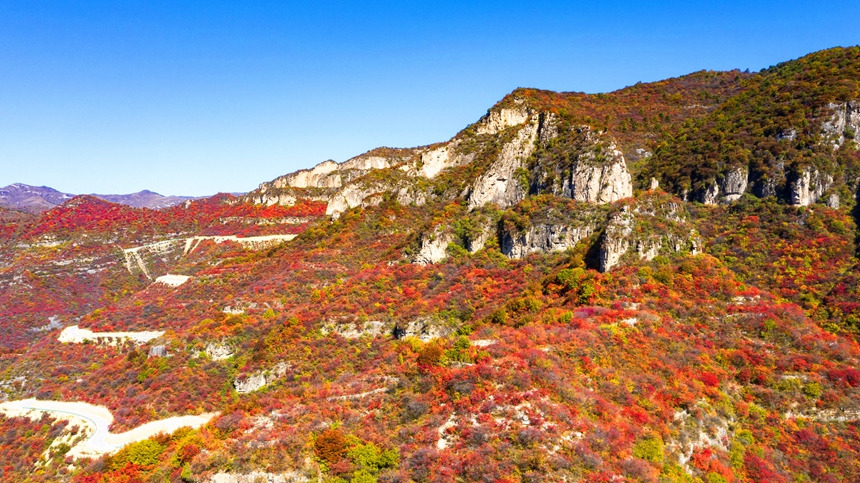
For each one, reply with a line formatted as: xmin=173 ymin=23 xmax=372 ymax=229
xmin=0 ymin=183 xmax=196 ymax=213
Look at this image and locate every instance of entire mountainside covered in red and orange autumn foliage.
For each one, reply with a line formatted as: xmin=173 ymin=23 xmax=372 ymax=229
xmin=0 ymin=47 xmax=860 ymax=483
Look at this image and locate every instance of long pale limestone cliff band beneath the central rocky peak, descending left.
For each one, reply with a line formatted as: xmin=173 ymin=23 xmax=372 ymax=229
xmin=246 ymin=93 xmax=633 ymax=225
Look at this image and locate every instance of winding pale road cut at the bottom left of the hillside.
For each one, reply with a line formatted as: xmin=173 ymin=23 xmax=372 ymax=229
xmin=0 ymin=399 xmax=218 ymax=458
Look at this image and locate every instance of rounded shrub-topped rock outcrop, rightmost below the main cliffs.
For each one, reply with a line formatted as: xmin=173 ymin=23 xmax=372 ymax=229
xmin=598 ymin=196 xmax=702 ymax=272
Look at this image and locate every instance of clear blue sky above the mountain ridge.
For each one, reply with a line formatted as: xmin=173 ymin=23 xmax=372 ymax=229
xmin=0 ymin=0 xmax=860 ymax=195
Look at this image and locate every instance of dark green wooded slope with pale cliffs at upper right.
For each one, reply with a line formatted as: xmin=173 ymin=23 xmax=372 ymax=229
xmin=641 ymin=47 xmax=860 ymax=206
